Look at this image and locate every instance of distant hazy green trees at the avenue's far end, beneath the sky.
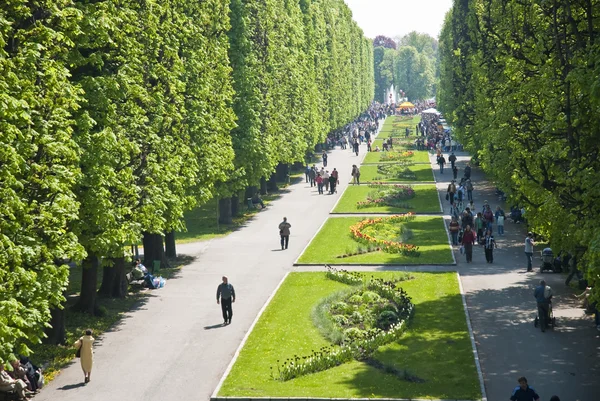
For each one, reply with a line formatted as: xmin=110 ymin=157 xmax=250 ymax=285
xmin=373 ymin=31 xmax=438 ymax=102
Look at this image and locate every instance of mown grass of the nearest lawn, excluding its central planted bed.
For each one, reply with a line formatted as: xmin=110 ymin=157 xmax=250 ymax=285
xmin=218 ymin=272 xmax=481 ymax=400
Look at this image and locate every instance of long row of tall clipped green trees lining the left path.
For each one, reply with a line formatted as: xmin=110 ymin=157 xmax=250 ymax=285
xmin=0 ymin=0 xmax=373 ymax=358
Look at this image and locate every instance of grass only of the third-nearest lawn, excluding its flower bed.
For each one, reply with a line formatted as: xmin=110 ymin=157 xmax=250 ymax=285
xmin=333 ymin=185 xmax=441 ymax=213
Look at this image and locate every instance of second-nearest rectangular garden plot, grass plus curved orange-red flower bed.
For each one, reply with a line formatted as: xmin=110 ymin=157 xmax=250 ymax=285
xmin=298 ymin=215 xmax=454 ymax=265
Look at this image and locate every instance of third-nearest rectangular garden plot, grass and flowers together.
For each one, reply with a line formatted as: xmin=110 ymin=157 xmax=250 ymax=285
xmin=333 ymin=183 xmax=441 ymax=213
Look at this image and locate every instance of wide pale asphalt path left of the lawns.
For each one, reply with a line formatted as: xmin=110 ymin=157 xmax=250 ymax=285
xmin=35 ymin=126 xmax=380 ymax=401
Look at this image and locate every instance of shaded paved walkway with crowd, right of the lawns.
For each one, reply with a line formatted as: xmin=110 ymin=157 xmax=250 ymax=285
xmin=432 ymin=152 xmax=600 ymax=401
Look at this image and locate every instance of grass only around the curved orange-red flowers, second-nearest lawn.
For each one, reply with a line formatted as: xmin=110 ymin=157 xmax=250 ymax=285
xmin=298 ymin=216 xmax=454 ymax=265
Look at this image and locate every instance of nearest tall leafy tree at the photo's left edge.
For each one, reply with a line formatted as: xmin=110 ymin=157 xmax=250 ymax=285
xmin=0 ymin=0 xmax=83 ymax=360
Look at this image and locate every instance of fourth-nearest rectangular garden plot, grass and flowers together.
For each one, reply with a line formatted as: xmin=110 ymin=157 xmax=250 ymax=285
xmin=360 ymin=162 xmax=434 ymax=184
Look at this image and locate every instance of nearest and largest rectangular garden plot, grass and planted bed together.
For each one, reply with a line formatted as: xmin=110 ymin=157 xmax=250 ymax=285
xmin=218 ymin=272 xmax=481 ymax=400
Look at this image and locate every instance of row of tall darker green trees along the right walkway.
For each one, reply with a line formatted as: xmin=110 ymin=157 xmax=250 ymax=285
xmin=438 ymin=0 xmax=600 ymax=296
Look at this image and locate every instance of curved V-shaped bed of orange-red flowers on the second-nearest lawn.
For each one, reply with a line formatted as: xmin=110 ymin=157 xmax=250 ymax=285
xmin=350 ymin=213 xmax=420 ymax=257
